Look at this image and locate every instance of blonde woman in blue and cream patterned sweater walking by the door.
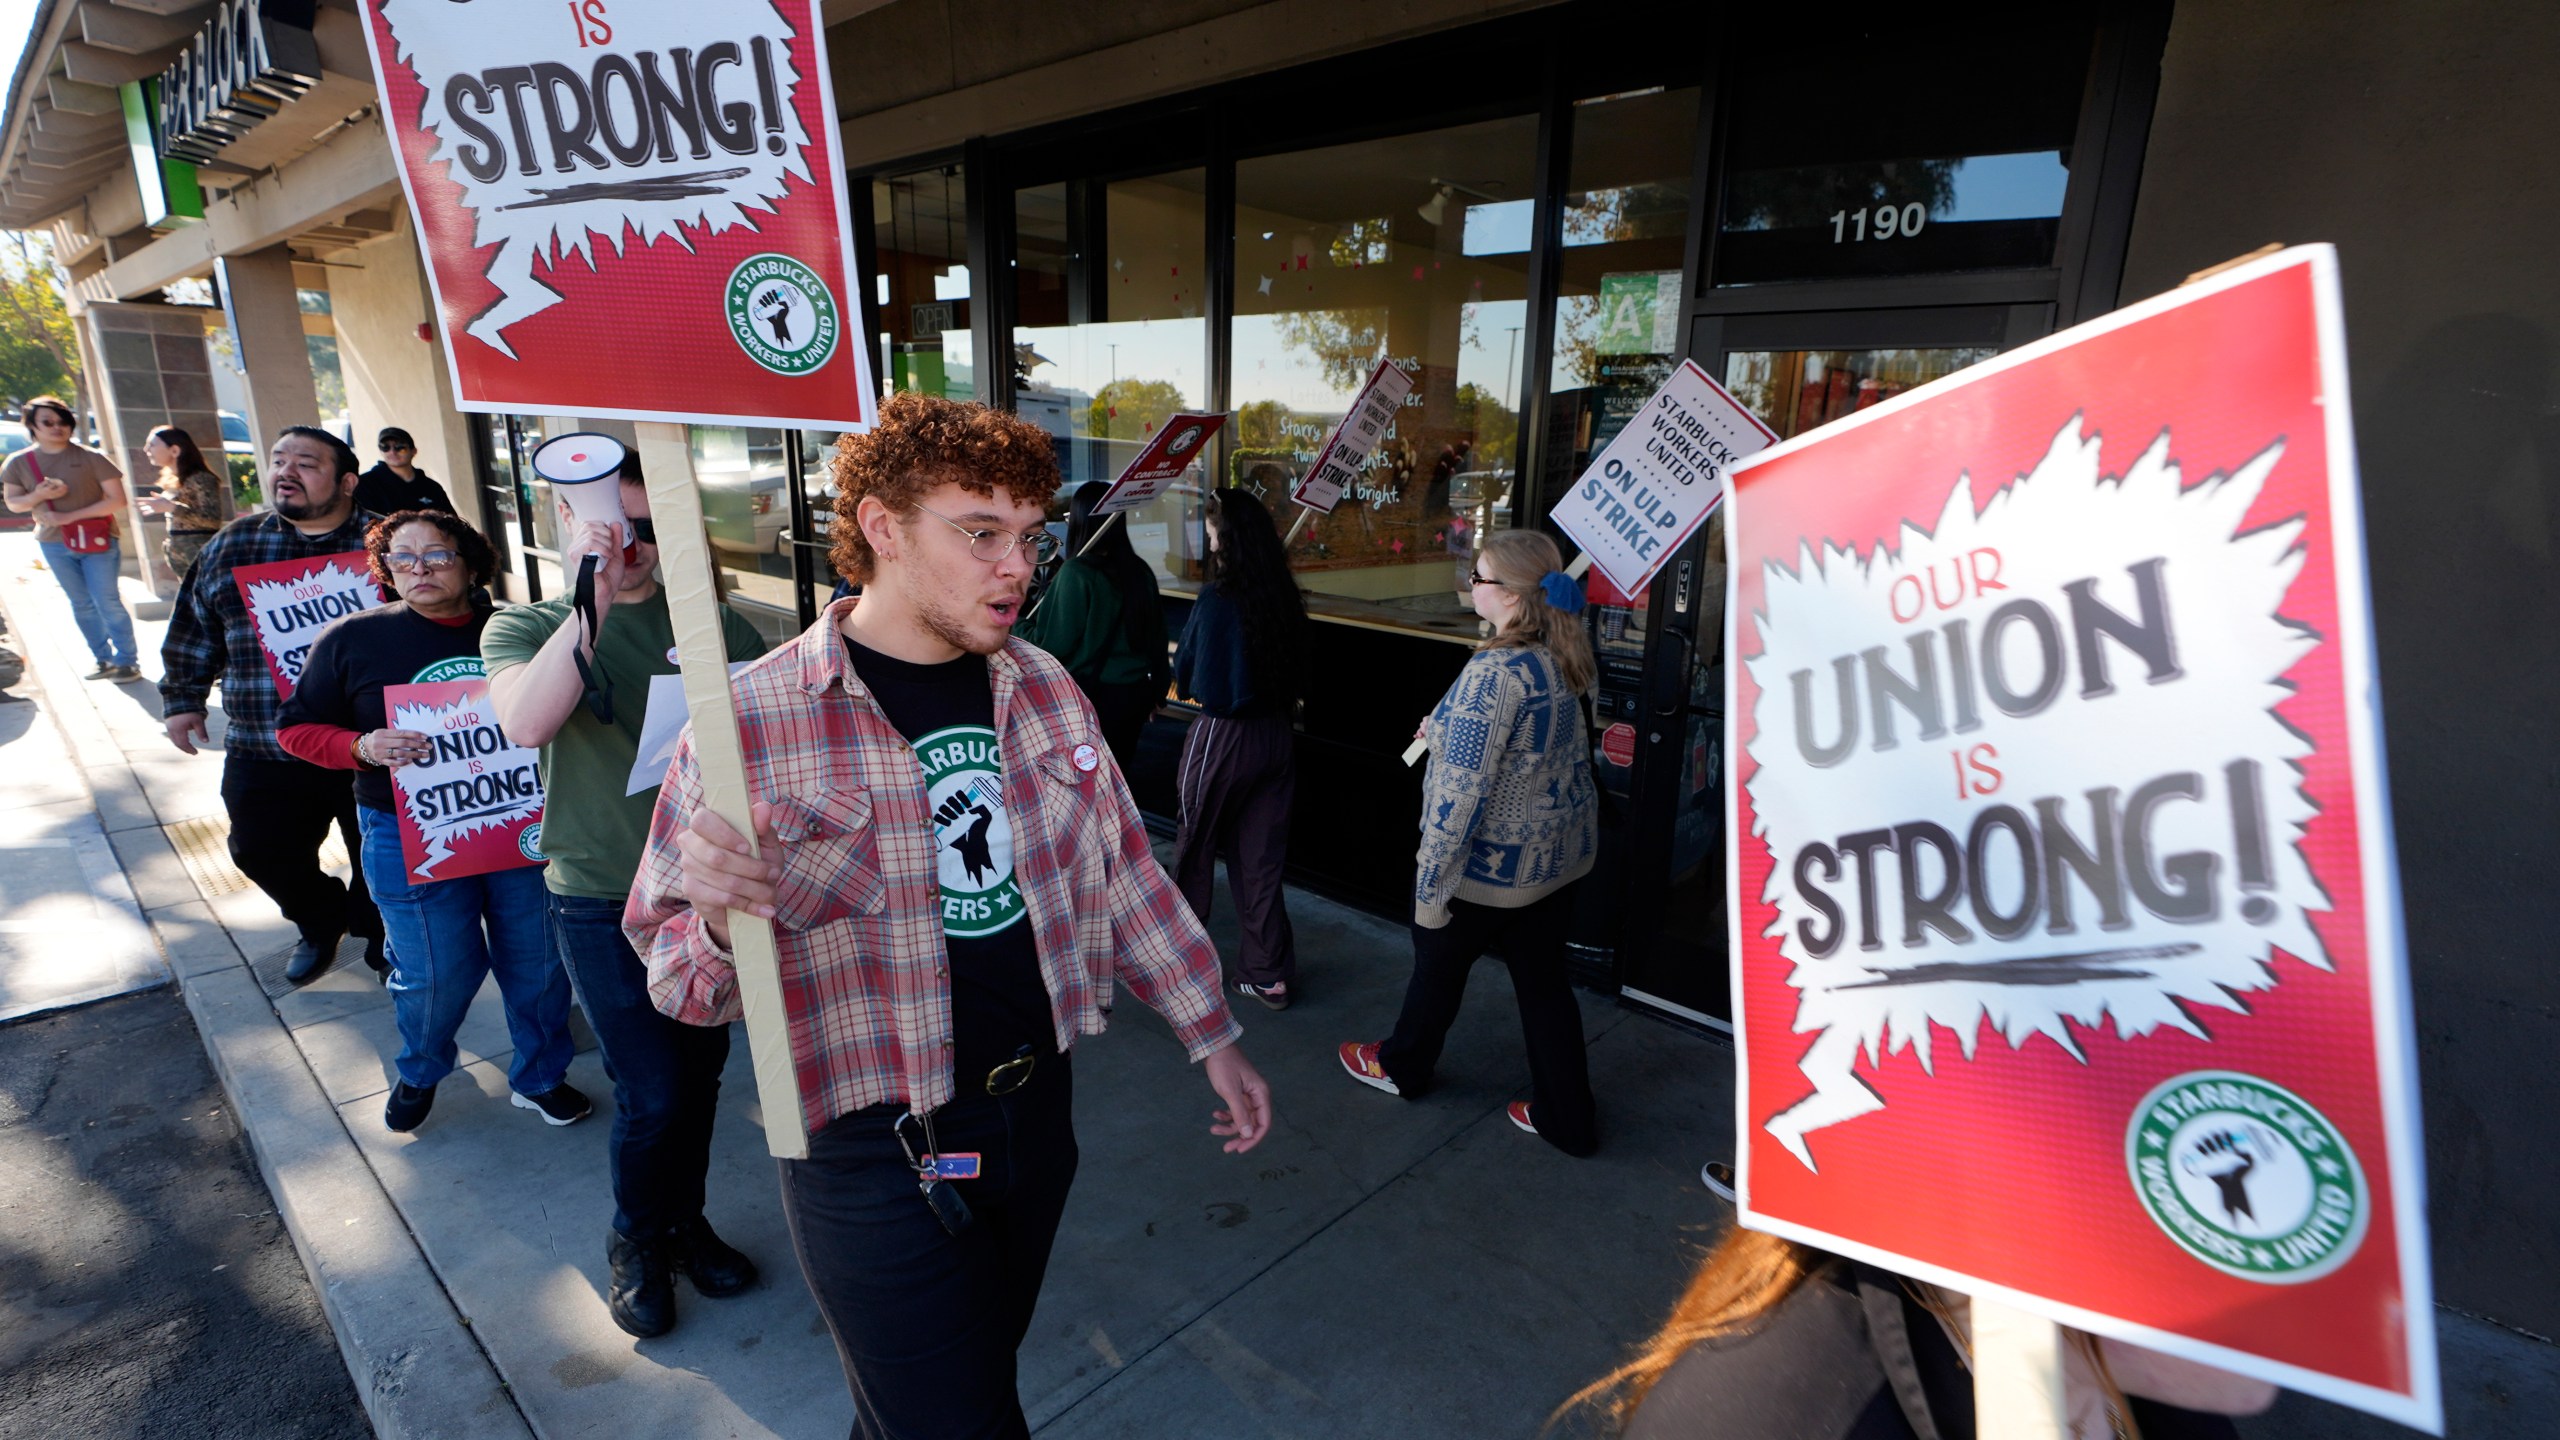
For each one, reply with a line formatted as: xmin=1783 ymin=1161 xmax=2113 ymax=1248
xmin=1339 ymin=530 xmax=1600 ymax=1156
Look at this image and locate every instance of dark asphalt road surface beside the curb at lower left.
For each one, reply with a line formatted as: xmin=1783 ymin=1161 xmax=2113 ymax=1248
xmin=0 ymin=989 xmax=371 ymax=1440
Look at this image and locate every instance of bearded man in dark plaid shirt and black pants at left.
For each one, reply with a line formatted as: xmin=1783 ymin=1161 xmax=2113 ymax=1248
xmin=161 ymin=425 xmax=389 ymax=984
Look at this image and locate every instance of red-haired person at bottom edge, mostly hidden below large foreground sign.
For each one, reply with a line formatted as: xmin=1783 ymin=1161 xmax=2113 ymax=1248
xmin=1559 ymin=1225 xmax=2276 ymax=1440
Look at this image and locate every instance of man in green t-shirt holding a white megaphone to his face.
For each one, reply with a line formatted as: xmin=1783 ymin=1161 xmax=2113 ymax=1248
xmin=481 ymin=433 xmax=765 ymax=1340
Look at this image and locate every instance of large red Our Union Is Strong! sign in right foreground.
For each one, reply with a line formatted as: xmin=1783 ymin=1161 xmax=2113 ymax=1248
xmin=1725 ymin=246 xmax=2440 ymax=1427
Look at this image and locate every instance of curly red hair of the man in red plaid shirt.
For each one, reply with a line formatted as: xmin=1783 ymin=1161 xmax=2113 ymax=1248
xmin=827 ymin=392 xmax=1060 ymax=584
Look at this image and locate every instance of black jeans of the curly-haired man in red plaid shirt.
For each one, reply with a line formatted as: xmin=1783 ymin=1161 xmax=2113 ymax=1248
xmin=776 ymin=1053 xmax=1075 ymax=1440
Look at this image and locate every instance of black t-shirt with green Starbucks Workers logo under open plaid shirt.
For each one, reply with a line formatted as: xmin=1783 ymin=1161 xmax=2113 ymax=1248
xmin=845 ymin=638 xmax=1057 ymax=1081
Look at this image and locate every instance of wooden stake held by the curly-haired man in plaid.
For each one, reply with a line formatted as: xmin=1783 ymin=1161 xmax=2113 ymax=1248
xmin=632 ymin=420 xmax=809 ymax=1161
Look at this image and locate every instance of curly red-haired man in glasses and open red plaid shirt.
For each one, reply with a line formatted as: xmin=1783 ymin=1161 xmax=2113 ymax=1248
xmin=625 ymin=392 xmax=1270 ymax=1437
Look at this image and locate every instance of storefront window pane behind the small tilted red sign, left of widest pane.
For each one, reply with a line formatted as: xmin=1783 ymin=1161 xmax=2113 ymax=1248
xmin=1014 ymin=169 xmax=1208 ymax=520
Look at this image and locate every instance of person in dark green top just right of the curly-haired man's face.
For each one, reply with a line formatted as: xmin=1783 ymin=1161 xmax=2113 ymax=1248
xmin=1014 ymin=479 xmax=1172 ymax=774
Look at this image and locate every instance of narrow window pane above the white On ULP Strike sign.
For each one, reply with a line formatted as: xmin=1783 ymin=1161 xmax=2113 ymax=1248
xmin=1523 ymin=90 xmax=1697 ymax=520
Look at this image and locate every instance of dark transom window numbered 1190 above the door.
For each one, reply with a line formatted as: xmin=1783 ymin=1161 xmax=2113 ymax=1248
xmin=1715 ymin=15 xmax=2092 ymax=284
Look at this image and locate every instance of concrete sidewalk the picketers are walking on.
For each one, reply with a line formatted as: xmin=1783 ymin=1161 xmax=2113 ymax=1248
xmin=0 ymin=538 xmax=2555 ymax=1440
